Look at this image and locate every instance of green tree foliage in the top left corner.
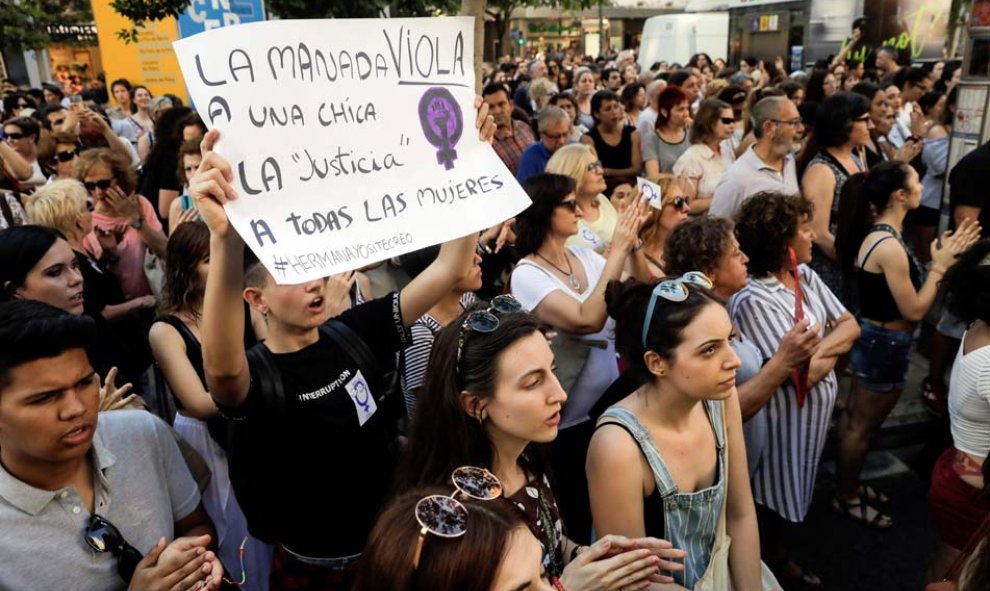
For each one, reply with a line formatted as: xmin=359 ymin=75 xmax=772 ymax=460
xmin=0 ymin=0 xmax=93 ymax=50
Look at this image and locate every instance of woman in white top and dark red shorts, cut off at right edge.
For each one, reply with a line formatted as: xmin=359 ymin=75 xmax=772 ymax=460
xmin=928 ymin=240 xmax=990 ymax=591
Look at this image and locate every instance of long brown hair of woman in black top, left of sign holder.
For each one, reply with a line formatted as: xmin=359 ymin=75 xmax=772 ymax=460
xmin=159 ymin=222 xmax=210 ymax=318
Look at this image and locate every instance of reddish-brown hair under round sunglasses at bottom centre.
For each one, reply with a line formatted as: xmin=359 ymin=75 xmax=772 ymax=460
xmin=353 ymin=487 xmax=526 ymax=591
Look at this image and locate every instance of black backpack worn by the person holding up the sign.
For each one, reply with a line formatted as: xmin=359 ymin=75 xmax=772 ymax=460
xmin=227 ymin=320 xmax=405 ymax=543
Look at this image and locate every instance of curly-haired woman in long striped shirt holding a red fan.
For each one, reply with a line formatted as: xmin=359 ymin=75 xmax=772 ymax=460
xmin=730 ymin=193 xmax=859 ymax=589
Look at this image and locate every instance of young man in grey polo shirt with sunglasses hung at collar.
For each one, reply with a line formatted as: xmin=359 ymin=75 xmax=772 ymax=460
xmin=0 ymin=300 xmax=223 ymax=591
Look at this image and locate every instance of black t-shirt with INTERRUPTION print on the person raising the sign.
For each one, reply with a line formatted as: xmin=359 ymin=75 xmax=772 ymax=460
xmin=224 ymin=293 xmax=409 ymax=558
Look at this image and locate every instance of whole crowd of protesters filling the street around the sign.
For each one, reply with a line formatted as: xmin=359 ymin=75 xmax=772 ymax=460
xmin=0 ymin=30 xmax=990 ymax=591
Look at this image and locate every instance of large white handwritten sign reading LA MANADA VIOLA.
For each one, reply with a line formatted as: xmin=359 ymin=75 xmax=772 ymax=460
xmin=175 ymin=18 xmax=529 ymax=284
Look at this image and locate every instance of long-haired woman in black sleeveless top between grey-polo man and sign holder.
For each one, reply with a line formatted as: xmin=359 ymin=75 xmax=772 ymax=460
xmin=148 ymin=222 xmax=272 ymax=590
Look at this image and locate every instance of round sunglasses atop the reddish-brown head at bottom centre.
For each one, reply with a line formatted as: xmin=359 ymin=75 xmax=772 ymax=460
xmin=413 ymin=466 xmax=502 ymax=569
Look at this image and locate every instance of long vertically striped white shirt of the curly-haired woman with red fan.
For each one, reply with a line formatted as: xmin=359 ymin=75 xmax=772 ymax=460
xmin=729 ymin=265 xmax=846 ymax=522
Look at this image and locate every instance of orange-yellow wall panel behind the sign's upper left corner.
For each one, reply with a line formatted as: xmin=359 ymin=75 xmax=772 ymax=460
xmin=92 ymin=0 xmax=189 ymax=103
